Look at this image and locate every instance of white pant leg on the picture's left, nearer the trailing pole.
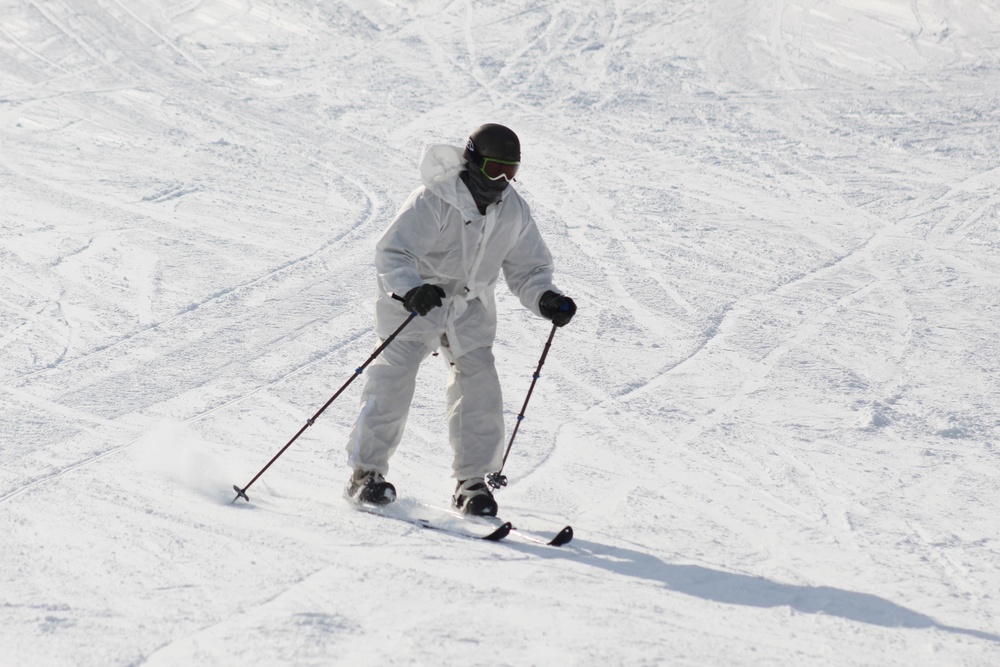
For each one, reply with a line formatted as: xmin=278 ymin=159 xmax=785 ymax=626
xmin=347 ymin=338 xmax=430 ymax=475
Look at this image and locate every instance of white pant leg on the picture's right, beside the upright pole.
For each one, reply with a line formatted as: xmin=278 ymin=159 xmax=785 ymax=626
xmin=447 ymin=347 xmax=504 ymax=480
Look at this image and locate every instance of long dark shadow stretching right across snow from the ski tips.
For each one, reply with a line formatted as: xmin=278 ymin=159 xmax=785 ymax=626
xmin=545 ymin=539 xmax=1000 ymax=642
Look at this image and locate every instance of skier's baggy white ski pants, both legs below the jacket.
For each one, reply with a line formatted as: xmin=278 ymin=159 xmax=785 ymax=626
xmin=347 ymin=338 xmax=504 ymax=480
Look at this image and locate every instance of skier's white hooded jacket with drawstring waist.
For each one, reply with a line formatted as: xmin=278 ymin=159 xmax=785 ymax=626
xmin=375 ymin=144 xmax=561 ymax=357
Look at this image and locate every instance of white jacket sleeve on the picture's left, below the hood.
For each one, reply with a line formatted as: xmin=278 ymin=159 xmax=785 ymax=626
xmin=375 ymin=187 xmax=442 ymax=296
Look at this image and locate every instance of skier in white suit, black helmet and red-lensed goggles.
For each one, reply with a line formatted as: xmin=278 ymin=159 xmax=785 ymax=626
xmin=347 ymin=123 xmax=576 ymax=516
